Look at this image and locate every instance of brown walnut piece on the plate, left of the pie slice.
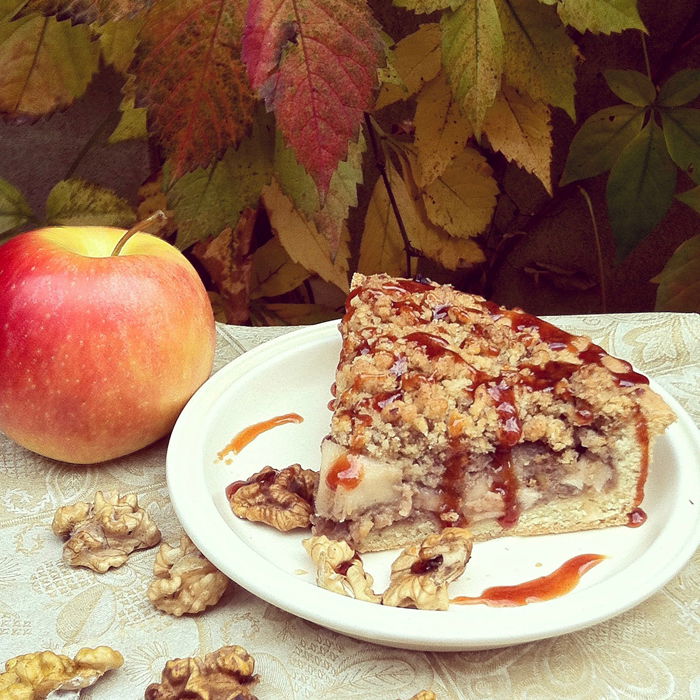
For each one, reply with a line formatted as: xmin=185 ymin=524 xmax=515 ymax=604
xmin=228 ymin=464 xmax=318 ymax=532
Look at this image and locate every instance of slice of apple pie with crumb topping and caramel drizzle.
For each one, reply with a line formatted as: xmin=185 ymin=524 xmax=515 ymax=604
xmin=313 ymin=275 xmax=674 ymax=552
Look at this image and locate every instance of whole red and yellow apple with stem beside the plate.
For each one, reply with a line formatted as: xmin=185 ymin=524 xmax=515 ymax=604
xmin=0 ymin=226 xmax=215 ymax=464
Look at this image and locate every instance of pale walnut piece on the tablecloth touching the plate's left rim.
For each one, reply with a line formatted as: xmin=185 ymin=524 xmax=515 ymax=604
xmin=147 ymin=535 xmax=229 ymax=617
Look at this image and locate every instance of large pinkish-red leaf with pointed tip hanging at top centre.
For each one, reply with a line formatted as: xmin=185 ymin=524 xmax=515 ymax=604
xmin=243 ymin=0 xmax=385 ymax=195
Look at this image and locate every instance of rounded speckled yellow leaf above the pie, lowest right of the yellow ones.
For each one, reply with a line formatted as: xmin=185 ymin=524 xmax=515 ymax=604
xmin=423 ymin=148 xmax=498 ymax=238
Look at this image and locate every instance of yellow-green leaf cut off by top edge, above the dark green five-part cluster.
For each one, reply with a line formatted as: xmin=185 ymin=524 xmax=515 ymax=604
xmin=547 ymin=0 xmax=646 ymax=34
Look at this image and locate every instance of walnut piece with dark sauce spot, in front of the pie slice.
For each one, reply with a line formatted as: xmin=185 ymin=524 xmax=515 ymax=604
xmin=382 ymin=527 xmax=472 ymax=610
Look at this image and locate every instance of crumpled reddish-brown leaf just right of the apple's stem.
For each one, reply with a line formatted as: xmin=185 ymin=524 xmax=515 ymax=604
xmin=192 ymin=209 xmax=257 ymax=324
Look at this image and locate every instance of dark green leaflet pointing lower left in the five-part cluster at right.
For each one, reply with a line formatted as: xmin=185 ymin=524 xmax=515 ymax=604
xmin=559 ymin=104 xmax=644 ymax=185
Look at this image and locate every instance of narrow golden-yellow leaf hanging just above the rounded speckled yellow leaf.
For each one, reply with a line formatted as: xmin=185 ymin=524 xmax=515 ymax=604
xmin=415 ymin=73 xmax=472 ymax=185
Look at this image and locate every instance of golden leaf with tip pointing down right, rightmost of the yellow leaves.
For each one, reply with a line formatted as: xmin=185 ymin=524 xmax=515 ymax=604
xmin=484 ymin=85 xmax=552 ymax=195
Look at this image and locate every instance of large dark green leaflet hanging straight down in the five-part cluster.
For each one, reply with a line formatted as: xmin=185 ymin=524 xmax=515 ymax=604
xmin=606 ymin=119 xmax=676 ymax=261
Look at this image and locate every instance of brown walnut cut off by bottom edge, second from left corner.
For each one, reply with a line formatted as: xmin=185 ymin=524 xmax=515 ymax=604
xmin=144 ymin=646 xmax=258 ymax=700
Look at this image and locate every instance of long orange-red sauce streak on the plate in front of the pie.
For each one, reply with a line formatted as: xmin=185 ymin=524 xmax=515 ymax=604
xmin=450 ymin=554 xmax=605 ymax=607
